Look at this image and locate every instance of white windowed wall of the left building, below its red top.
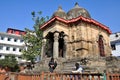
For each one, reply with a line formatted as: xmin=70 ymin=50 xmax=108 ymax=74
xmin=0 ymin=33 xmax=24 ymax=59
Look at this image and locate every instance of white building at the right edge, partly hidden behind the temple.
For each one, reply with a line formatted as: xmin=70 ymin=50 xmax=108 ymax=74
xmin=110 ymin=32 xmax=120 ymax=57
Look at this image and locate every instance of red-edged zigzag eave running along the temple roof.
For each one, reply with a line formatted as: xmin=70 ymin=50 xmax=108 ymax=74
xmin=40 ymin=16 xmax=112 ymax=34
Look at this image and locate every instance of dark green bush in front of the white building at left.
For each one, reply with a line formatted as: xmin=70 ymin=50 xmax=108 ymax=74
xmin=0 ymin=54 xmax=18 ymax=68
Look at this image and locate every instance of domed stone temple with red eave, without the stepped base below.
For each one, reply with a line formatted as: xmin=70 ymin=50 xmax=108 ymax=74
xmin=40 ymin=3 xmax=111 ymax=59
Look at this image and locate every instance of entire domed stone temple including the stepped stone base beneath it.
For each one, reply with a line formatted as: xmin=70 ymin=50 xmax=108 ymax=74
xmin=33 ymin=3 xmax=120 ymax=71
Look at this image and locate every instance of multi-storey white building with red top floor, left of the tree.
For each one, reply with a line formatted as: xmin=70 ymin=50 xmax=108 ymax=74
xmin=0 ymin=28 xmax=25 ymax=61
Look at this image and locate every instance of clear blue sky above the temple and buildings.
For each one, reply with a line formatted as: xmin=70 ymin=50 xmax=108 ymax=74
xmin=0 ymin=0 xmax=120 ymax=33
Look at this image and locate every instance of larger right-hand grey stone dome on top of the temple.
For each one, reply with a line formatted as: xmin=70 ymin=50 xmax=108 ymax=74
xmin=67 ymin=3 xmax=91 ymax=19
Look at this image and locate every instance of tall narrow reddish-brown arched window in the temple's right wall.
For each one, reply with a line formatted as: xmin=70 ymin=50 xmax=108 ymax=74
xmin=98 ymin=35 xmax=105 ymax=57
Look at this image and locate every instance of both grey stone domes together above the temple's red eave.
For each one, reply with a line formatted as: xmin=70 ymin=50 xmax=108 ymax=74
xmin=52 ymin=3 xmax=91 ymax=19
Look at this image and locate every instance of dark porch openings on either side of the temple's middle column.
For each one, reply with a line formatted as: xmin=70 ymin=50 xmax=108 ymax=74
xmin=45 ymin=32 xmax=65 ymax=58
